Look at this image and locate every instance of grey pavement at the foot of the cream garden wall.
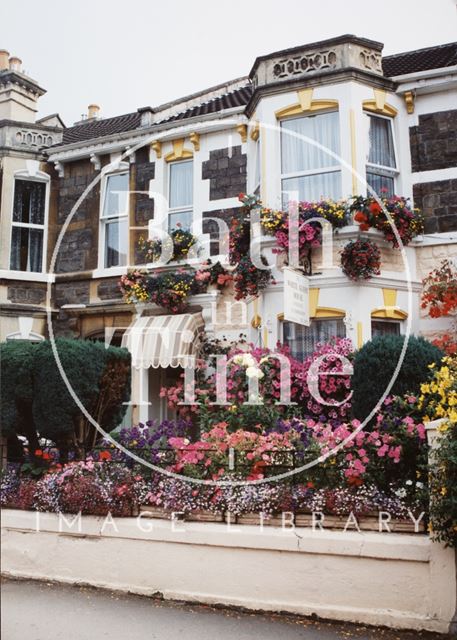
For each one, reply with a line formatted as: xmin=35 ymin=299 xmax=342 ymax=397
xmin=1 ymin=579 xmax=443 ymax=640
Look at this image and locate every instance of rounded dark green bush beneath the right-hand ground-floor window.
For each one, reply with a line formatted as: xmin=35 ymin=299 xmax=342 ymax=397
xmin=352 ymin=335 xmax=443 ymax=420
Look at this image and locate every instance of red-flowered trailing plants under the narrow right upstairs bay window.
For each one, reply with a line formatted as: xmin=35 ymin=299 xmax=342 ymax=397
xmin=349 ymin=196 xmax=424 ymax=247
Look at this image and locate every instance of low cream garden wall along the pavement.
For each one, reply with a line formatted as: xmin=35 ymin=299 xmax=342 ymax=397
xmin=2 ymin=509 xmax=456 ymax=633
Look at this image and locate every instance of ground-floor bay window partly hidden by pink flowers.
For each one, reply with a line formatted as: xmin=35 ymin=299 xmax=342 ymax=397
xmin=282 ymin=318 xmax=346 ymax=361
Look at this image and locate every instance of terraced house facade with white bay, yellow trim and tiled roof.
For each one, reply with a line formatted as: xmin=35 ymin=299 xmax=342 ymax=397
xmin=0 ymin=35 xmax=457 ymax=419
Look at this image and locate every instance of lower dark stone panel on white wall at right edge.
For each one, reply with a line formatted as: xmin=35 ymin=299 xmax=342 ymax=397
xmin=413 ymin=180 xmax=457 ymax=233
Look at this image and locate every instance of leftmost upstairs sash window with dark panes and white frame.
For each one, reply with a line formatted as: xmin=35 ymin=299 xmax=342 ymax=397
xmin=10 ymin=179 xmax=46 ymax=273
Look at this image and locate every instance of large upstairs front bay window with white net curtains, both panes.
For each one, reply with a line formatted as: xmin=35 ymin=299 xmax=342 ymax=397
xmin=281 ymin=111 xmax=342 ymax=207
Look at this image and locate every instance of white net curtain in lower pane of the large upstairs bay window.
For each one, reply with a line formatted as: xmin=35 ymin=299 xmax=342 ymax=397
xmin=282 ymin=171 xmax=341 ymax=207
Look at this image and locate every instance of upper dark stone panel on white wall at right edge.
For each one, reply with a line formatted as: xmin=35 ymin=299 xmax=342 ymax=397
xmin=409 ymin=109 xmax=457 ymax=171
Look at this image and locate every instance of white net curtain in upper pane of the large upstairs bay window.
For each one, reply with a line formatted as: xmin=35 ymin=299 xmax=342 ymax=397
xmin=281 ymin=112 xmax=340 ymax=174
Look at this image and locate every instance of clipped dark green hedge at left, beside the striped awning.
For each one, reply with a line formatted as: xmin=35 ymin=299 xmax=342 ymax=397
xmin=0 ymin=339 xmax=130 ymax=448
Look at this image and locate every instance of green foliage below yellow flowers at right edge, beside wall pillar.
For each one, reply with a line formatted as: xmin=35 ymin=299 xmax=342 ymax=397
xmin=430 ymin=422 xmax=457 ymax=547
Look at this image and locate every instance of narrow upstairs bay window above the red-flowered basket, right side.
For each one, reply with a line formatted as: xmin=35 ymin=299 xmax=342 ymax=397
xmin=367 ymin=114 xmax=398 ymax=196
